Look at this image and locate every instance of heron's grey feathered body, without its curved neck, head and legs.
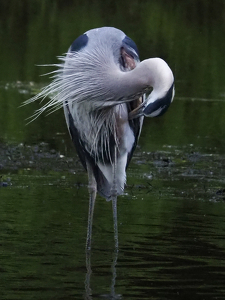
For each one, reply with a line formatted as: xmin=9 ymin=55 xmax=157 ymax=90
xmin=63 ymin=28 xmax=143 ymax=199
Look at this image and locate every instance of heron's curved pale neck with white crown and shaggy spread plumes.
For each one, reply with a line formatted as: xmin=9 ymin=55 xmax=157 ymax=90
xmin=24 ymin=44 xmax=174 ymax=121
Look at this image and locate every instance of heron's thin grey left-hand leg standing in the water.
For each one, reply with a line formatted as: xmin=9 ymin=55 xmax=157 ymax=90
xmin=86 ymin=162 xmax=97 ymax=250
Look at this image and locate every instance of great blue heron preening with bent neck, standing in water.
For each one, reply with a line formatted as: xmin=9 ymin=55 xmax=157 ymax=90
xmin=26 ymin=27 xmax=174 ymax=247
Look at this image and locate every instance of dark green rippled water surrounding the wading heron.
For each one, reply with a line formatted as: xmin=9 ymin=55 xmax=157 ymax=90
xmin=0 ymin=0 xmax=225 ymax=300
